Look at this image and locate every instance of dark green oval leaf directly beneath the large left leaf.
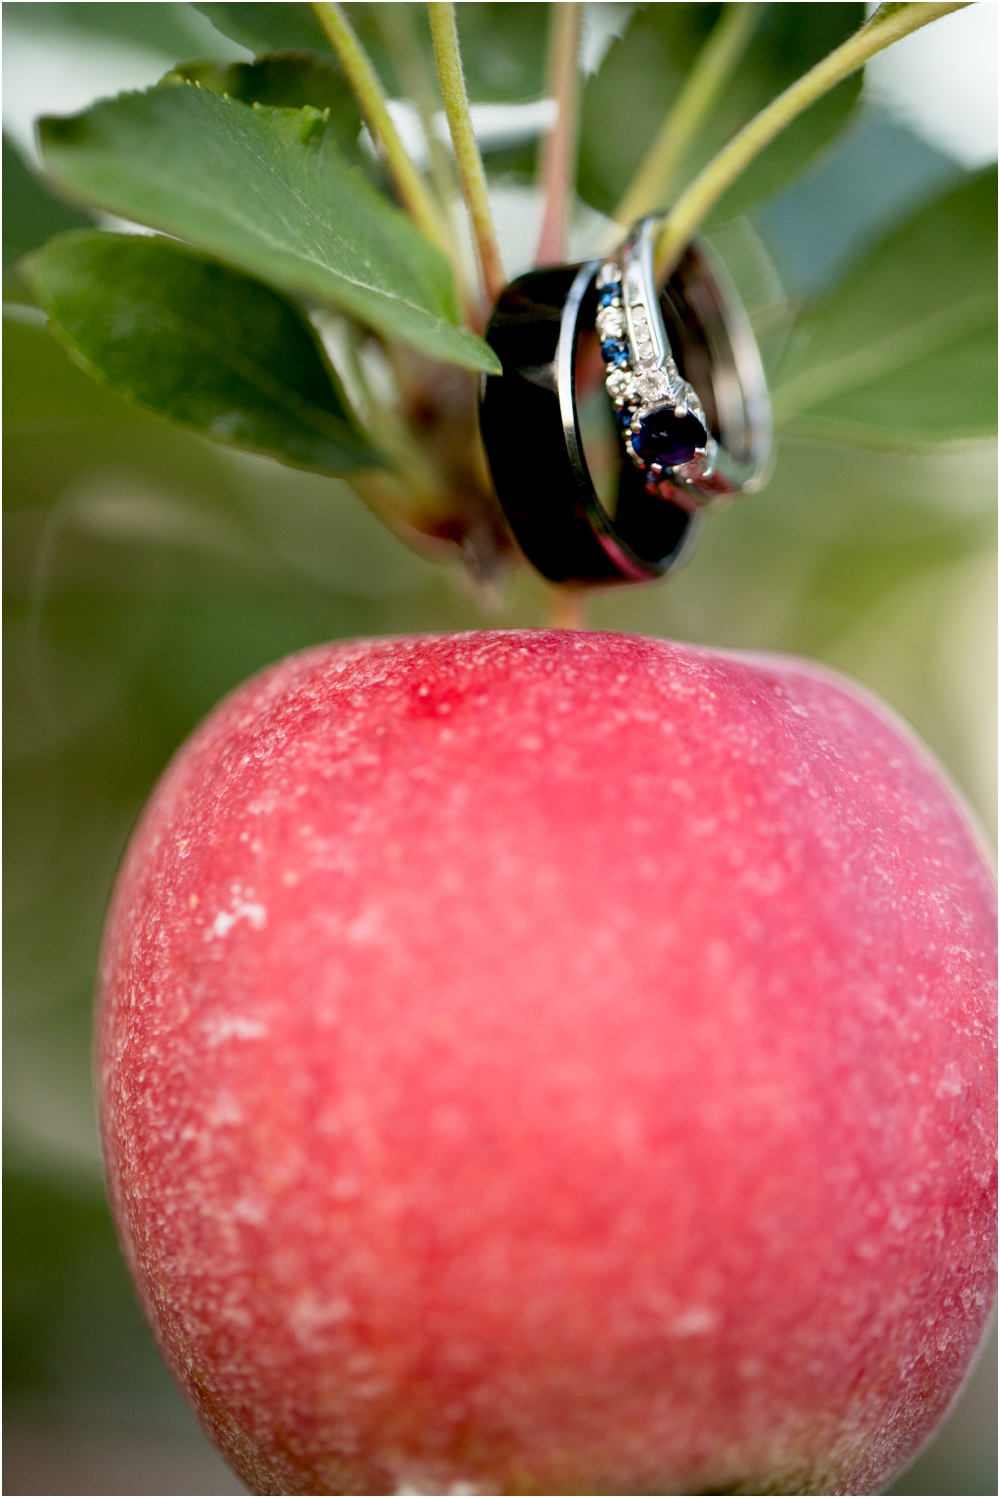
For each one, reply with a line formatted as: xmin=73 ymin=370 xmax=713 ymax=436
xmin=24 ymin=229 xmax=374 ymax=473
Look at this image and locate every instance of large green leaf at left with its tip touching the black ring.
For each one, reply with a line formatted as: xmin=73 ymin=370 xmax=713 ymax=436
xmin=39 ymin=84 xmax=499 ymax=370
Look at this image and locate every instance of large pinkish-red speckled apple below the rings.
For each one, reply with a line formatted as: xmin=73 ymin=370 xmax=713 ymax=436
xmin=99 ymin=631 xmax=996 ymax=1494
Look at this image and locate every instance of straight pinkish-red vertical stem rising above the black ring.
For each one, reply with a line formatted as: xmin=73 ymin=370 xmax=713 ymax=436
xmin=534 ymin=0 xmax=581 ymax=265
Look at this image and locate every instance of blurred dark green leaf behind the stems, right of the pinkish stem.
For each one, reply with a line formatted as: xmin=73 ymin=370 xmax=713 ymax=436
xmin=579 ymin=3 xmax=864 ymax=222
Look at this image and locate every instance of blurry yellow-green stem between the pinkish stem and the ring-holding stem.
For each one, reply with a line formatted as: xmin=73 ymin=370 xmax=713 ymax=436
xmin=615 ymin=4 xmax=763 ymax=226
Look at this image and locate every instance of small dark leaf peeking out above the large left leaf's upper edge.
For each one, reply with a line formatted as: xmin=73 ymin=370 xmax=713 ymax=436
xmin=169 ymin=52 xmax=362 ymax=159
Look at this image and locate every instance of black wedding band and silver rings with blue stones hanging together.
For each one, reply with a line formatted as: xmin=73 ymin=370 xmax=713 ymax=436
xmin=481 ymin=217 xmax=771 ymax=586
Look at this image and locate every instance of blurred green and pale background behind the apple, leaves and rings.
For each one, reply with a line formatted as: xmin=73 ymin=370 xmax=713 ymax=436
xmin=3 ymin=3 xmax=997 ymax=1494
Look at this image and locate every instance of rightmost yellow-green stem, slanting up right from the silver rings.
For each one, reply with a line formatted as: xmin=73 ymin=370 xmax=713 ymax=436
xmin=656 ymin=0 xmax=969 ymax=283
